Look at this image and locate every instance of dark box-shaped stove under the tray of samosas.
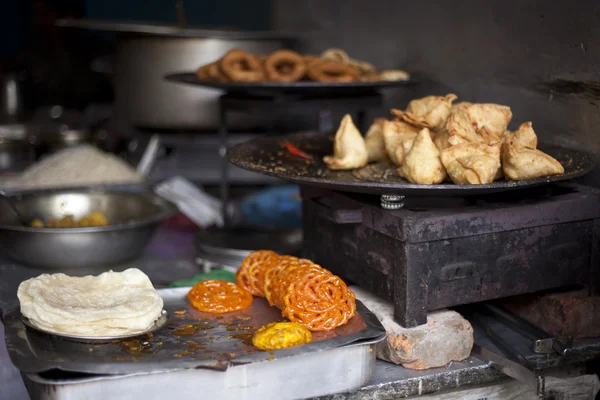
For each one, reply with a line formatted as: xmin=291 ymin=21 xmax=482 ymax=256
xmin=302 ymin=183 xmax=600 ymax=327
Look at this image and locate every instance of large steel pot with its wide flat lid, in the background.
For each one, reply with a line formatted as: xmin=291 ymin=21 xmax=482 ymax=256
xmin=58 ymin=20 xmax=287 ymax=130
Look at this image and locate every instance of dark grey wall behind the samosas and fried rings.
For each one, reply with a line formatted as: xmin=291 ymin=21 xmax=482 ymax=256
xmin=274 ymin=0 xmax=600 ymax=187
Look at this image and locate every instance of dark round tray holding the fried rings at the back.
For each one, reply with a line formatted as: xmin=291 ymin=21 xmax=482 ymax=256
xmin=165 ymin=72 xmax=420 ymax=97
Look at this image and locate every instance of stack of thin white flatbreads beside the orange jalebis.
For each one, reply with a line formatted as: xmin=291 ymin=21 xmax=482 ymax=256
xmin=17 ymin=268 xmax=163 ymax=337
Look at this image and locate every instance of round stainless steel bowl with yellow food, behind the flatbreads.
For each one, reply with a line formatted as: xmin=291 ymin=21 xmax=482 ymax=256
xmin=0 ymin=189 xmax=176 ymax=270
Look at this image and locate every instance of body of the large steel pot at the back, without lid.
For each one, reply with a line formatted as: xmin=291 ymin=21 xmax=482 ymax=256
xmin=115 ymin=36 xmax=283 ymax=129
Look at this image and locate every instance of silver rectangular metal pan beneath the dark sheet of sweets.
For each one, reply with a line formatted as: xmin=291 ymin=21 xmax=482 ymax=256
xmin=22 ymin=343 xmax=375 ymax=400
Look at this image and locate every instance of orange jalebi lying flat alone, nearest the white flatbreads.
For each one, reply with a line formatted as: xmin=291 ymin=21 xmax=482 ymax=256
xmin=187 ymin=280 xmax=252 ymax=314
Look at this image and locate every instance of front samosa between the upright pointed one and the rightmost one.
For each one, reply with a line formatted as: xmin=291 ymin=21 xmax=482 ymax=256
xmin=440 ymin=143 xmax=501 ymax=185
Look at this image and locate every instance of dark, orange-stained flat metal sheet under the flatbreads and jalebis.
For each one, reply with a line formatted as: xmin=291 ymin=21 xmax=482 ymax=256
xmin=4 ymin=288 xmax=385 ymax=375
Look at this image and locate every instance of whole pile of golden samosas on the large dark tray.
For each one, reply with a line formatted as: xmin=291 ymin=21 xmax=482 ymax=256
xmin=323 ymin=94 xmax=564 ymax=185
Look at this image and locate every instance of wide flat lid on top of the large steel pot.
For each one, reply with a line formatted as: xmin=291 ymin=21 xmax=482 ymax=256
xmin=56 ymin=19 xmax=289 ymax=40
